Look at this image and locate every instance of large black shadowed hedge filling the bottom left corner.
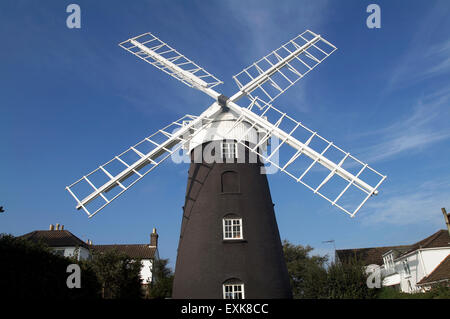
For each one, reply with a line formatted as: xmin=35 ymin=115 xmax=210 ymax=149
xmin=0 ymin=235 xmax=100 ymax=299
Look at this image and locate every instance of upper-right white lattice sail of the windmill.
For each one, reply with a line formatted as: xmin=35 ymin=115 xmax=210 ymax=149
xmin=231 ymin=30 xmax=337 ymax=105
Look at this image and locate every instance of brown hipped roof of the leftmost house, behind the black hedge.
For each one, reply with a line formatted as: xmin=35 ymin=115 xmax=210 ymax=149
xmin=19 ymin=230 xmax=89 ymax=249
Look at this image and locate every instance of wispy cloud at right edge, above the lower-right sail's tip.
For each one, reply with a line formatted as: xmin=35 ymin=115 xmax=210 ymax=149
xmin=358 ymin=90 xmax=450 ymax=163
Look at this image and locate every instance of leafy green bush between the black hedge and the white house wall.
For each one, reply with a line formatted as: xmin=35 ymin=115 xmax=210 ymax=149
xmin=86 ymin=249 xmax=142 ymax=299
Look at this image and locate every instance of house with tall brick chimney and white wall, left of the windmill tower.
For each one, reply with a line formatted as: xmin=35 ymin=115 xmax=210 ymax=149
xmin=91 ymin=228 xmax=159 ymax=285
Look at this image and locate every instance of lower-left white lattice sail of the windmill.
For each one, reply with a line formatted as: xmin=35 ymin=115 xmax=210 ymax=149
xmin=66 ymin=115 xmax=215 ymax=217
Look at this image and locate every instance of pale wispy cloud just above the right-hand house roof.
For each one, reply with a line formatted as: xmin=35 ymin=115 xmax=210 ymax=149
xmin=362 ymin=181 xmax=450 ymax=226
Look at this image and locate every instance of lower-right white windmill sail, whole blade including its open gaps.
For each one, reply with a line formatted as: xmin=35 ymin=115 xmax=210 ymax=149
xmin=220 ymin=97 xmax=386 ymax=217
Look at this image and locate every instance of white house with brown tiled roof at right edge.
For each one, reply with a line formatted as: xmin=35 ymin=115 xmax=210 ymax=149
xmin=336 ymin=230 xmax=450 ymax=293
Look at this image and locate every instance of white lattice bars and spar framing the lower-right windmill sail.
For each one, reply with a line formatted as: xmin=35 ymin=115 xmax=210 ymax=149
xmin=220 ymin=97 xmax=387 ymax=217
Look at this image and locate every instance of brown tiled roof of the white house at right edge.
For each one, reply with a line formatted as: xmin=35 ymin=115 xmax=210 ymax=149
xmin=336 ymin=229 xmax=450 ymax=266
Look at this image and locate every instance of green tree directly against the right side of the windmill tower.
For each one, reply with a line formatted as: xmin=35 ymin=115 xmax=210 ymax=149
xmin=283 ymin=240 xmax=328 ymax=299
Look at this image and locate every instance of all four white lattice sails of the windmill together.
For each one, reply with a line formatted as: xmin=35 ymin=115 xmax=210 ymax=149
xmin=66 ymin=30 xmax=386 ymax=217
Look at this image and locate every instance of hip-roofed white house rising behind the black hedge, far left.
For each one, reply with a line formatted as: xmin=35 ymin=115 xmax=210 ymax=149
xmin=19 ymin=224 xmax=91 ymax=260
